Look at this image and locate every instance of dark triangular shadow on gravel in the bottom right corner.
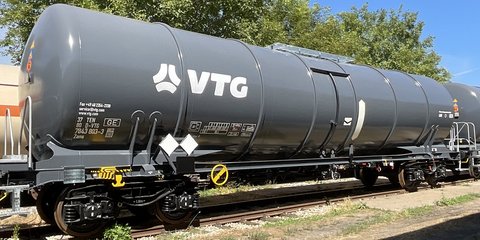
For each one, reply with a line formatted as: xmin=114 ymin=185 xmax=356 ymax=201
xmin=386 ymin=213 xmax=480 ymax=240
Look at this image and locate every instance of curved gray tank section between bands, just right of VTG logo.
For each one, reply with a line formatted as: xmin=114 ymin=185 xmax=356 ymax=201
xmin=251 ymin=47 xmax=317 ymax=157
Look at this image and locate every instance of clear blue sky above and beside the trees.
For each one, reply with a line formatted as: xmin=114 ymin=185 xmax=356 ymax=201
xmin=0 ymin=0 xmax=480 ymax=86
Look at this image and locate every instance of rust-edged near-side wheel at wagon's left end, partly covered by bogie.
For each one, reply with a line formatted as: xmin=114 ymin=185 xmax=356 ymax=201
xmin=54 ymin=188 xmax=107 ymax=238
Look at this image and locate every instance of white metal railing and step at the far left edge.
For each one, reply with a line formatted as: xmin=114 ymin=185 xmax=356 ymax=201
xmin=0 ymin=96 xmax=33 ymax=217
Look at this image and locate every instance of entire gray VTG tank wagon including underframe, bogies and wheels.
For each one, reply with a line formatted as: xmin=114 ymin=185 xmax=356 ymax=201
xmin=0 ymin=5 xmax=480 ymax=237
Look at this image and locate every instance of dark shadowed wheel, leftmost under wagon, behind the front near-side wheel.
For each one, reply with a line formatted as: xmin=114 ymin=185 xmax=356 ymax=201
xmin=35 ymin=186 xmax=60 ymax=224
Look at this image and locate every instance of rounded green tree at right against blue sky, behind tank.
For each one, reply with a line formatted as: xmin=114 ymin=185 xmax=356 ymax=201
xmin=302 ymin=5 xmax=450 ymax=82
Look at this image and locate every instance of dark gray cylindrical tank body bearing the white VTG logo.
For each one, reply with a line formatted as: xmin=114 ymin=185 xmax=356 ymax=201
xmin=20 ymin=5 xmax=453 ymax=162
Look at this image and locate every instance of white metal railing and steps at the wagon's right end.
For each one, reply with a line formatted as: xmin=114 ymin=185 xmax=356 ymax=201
xmin=448 ymin=122 xmax=480 ymax=178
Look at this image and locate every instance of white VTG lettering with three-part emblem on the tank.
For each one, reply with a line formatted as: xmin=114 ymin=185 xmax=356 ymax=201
xmin=153 ymin=63 xmax=248 ymax=98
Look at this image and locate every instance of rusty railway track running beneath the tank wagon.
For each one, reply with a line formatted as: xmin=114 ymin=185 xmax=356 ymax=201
xmin=0 ymin=175 xmax=472 ymax=239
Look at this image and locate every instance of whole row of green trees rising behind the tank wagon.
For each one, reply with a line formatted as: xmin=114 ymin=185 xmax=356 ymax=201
xmin=0 ymin=0 xmax=450 ymax=81
